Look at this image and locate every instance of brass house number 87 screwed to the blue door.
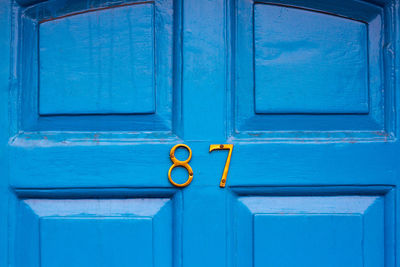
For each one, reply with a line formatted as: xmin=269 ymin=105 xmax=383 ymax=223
xmin=168 ymin=144 xmax=233 ymax=187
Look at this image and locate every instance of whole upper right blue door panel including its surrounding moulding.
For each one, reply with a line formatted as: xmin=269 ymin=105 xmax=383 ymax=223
xmin=236 ymin=0 xmax=386 ymax=140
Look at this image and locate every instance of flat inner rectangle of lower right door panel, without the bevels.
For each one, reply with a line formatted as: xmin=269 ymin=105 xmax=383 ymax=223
xmin=254 ymin=217 xmax=364 ymax=266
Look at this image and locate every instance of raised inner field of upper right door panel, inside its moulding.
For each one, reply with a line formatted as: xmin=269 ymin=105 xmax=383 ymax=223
xmin=254 ymin=4 xmax=369 ymax=113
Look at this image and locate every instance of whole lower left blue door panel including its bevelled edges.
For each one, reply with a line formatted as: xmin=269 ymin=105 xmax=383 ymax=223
xmin=16 ymin=198 xmax=178 ymax=267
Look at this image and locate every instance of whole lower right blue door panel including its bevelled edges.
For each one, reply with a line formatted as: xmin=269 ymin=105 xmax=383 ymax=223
xmin=232 ymin=193 xmax=390 ymax=266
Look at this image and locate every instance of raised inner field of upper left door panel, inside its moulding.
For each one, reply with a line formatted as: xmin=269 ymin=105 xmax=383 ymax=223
xmin=39 ymin=3 xmax=155 ymax=115
